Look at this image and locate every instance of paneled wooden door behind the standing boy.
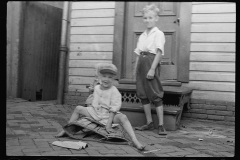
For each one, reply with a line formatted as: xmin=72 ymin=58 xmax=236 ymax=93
xmin=120 ymin=2 xmax=179 ymax=83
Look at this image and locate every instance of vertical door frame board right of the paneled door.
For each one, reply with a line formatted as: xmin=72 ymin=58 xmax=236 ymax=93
xmin=178 ymin=2 xmax=192 ymax=82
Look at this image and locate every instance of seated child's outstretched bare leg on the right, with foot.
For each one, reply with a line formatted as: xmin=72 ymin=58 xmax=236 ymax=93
xmin=113 ymin=114 xmax=144 ymax=150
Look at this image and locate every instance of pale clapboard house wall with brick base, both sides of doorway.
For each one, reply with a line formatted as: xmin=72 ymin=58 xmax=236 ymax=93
xmin=65 ymin=2 xmax=236 ymax=121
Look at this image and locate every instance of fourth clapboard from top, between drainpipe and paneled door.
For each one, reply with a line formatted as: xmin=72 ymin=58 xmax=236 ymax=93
xmin=71 ymin=26 xmax=114 ymax=35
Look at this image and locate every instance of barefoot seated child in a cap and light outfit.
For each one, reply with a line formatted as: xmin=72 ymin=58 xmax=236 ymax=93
xmin=56 ymin=64 xmax=145 ymax=150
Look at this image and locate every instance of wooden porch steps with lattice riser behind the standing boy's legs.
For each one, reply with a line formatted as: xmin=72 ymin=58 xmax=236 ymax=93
xmin=118 ymin=85 xmax=192 ymax=131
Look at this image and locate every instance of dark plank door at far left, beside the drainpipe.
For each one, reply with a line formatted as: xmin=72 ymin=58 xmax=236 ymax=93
xmin=20 ymin=1 xmax=62 ymax=101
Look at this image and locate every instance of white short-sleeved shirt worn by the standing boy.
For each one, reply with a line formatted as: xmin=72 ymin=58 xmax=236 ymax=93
xmin=134 ymin=27 xmax=165 ymax=55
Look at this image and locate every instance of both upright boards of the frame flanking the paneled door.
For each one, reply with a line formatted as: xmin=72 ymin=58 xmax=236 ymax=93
xmin=113 ymin=1 xmax=192 ymax=83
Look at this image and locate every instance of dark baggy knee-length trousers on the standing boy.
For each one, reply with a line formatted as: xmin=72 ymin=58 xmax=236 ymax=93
xmin=136 ymin=52 xmax=164 ymax=107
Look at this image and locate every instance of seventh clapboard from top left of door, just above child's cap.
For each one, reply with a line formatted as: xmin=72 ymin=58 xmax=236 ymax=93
xmin=69 ymin=52 xmax=113 ymax=60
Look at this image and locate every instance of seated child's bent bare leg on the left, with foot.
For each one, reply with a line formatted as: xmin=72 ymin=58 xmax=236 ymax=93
xmin=55 ymin=106 xmax=91 ymax=137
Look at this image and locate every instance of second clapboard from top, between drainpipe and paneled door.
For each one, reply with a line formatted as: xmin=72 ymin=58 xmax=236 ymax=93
xmin=71 ymin=9 xmax=115 ymax=18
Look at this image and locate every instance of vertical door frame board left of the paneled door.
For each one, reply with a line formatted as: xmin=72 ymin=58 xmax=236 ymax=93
xmin=113 ymin=2 xmax=125 ymax=79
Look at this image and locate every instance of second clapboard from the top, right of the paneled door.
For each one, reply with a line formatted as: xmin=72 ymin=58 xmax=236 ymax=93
xmin=192 ymin=13 xmax=236 ymax=24
